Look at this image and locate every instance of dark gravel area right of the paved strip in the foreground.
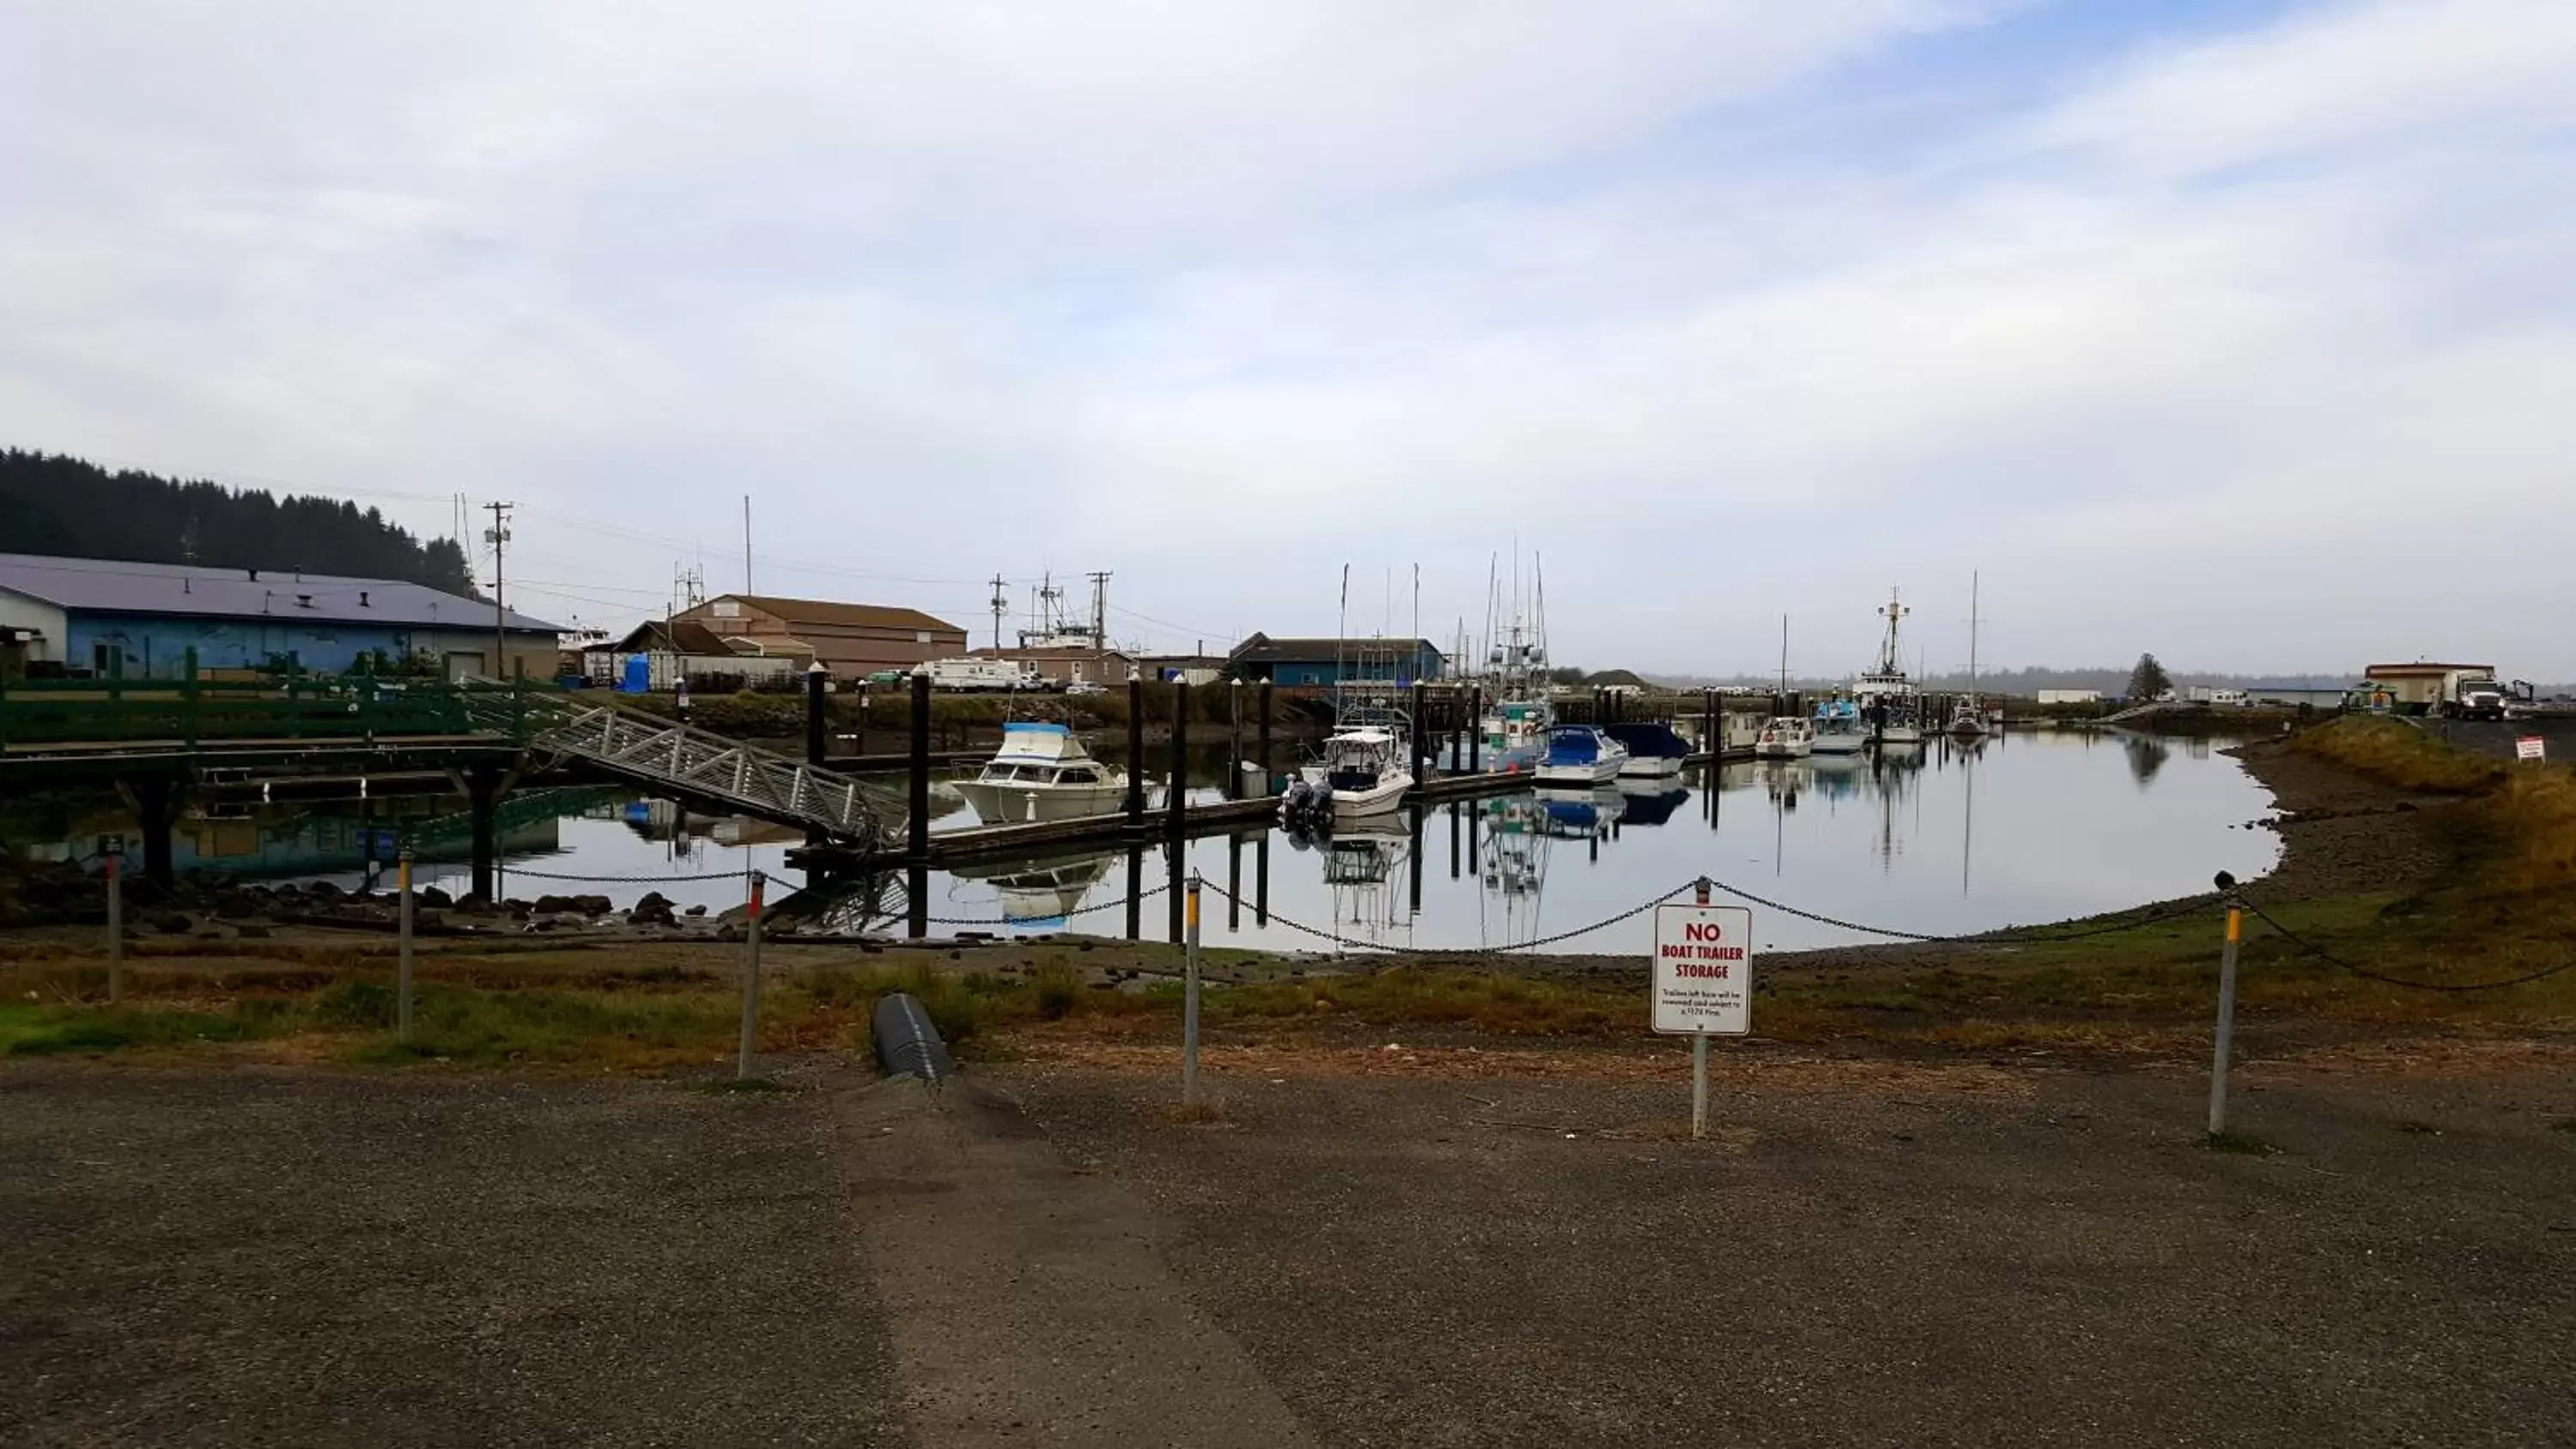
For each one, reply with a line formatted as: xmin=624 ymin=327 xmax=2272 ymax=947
xmin=1007 ymin=1052 xmax=2576 ymax=1449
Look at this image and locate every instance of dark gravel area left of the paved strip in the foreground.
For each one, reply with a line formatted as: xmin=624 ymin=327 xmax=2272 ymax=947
xmin=0 ymin=1063 xmax=904 ymax=1444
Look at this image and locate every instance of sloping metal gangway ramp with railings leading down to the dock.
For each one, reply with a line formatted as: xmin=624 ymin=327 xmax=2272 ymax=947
xmin=466 ymin=688 xmax=904 ymax=852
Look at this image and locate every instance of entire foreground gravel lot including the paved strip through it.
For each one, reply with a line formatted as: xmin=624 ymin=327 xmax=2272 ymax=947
xmin=0 ymin=1047 xmax=2576 ymax=1446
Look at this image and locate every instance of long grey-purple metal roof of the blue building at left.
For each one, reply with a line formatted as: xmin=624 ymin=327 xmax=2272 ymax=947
xmin=0 ymin=554 xmax=562 ymax=634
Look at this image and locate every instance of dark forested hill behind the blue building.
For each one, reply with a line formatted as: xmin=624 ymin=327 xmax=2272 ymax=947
xmin=0 ymin=448 xmax=474 ymax=595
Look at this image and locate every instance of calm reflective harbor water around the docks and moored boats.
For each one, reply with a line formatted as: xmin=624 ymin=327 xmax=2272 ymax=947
xmin=18 ymin=733 xmax=2277 ymax=955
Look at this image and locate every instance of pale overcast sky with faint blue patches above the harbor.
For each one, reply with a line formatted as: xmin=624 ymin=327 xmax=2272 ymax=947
xmin=0 ymin=0 xmax=2576 ymax=680
